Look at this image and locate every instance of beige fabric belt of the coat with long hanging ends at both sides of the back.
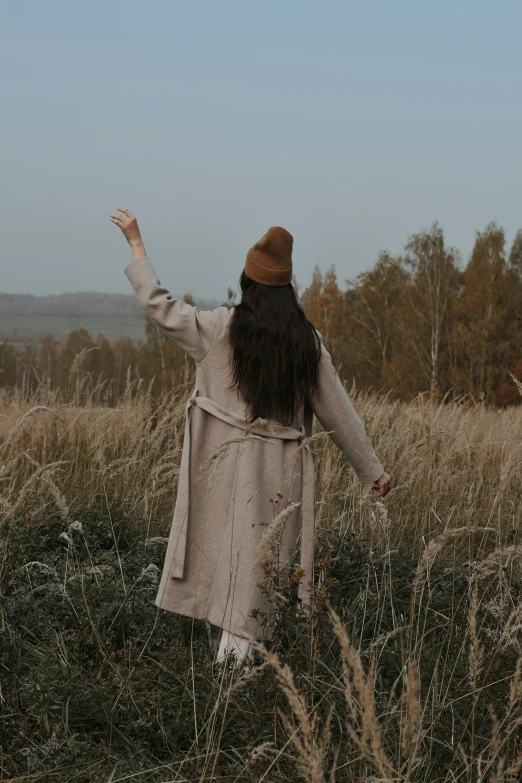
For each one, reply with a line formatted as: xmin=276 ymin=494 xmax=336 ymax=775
xmin=169 ymin=390 xmax=315 ymax=603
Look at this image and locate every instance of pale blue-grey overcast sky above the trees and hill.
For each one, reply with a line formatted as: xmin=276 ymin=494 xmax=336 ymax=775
xmin=0 ymin=0 xmax=522 ymax=300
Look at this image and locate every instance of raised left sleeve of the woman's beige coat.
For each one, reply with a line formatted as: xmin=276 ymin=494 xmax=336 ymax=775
xmin=124 ymin=256 xmax=216 ymax=362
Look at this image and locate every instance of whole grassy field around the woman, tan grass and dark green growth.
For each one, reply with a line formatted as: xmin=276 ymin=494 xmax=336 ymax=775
xmin=0 ymin=376 xmax=522 ymax=783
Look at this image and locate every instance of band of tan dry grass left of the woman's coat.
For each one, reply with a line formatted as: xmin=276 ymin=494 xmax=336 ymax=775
xmin=0 ymin=376 xmax=191 ymax=528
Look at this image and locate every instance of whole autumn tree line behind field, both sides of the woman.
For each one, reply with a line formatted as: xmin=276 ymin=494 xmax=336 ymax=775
xmin=0 ymin=221 xmax=522 ymax=406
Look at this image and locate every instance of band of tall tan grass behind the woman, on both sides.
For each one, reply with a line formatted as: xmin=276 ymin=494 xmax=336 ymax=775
xmin=0 ymin=376 xmax=522 ymax=559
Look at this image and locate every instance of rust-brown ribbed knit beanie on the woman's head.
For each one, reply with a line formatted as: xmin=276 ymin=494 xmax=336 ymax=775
xmin=245 ymin=226 xmax=294 ymax=285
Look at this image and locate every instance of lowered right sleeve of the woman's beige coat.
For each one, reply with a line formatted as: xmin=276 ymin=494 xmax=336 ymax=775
xmin=311 ymin=338 xmax=384 ymax=484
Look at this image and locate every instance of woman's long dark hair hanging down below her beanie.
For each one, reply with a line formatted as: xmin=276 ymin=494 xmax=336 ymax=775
xmin=229 ymin=270 xmax=321 ymax=426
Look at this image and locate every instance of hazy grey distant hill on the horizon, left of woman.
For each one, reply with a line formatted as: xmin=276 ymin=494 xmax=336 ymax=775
xmin=0 ymin=291 xmax=218 ymax=343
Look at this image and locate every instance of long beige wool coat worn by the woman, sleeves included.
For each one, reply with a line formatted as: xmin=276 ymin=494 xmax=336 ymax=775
xmin=125 ymin=256 xmax=383 ymax=639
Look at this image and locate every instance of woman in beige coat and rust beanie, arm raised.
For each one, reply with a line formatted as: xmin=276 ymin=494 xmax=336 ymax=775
xmin=110 ymin=207 xmax=390 ymax=660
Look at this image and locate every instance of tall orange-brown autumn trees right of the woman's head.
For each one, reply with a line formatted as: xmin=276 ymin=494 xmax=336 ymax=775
xmin=301 ymin=221 xmax=522 ymax=405
